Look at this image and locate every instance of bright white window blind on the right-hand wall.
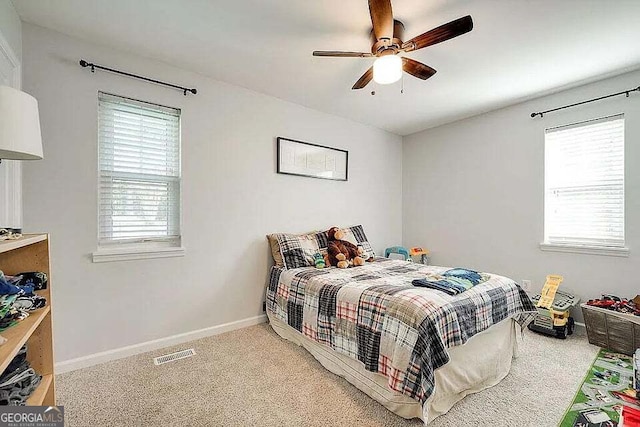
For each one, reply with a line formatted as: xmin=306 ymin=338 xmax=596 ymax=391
xmin=544 ymin=115 xmax=625 ymax=248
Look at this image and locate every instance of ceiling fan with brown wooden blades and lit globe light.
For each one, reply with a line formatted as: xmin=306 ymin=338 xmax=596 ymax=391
xmin=313 ymin=0 xmax=473 ymax=89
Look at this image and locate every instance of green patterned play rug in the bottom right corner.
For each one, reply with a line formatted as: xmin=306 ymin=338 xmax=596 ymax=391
xmin=560 ymin=349 xmax=640 ymax=427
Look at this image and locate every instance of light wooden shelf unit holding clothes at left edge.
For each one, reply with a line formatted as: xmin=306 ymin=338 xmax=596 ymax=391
xmin=0 ymin=234 xmax=56 ymax=406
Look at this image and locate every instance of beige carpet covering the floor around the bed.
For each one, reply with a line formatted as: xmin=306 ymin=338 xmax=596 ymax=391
xmin=57 ymin=324 xmax=597 ymax=427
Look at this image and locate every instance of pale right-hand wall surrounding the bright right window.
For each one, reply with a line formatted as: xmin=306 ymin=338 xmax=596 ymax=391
xmin=403 ymin=72 xmax=640 ymax=318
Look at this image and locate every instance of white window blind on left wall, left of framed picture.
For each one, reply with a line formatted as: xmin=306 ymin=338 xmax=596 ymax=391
xmin=98 ymin=93 xmax=180 ymax=245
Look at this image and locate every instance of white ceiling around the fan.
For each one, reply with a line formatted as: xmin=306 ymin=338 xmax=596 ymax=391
xmin=13 ymin=0 xmax=640 ymax=135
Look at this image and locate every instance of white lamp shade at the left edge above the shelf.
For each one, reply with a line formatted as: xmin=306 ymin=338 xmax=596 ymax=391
xmin=0 ymin=86 xmax=42 ymax=160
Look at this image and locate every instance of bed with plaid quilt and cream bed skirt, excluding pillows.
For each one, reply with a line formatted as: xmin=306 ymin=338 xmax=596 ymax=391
xmin=266 ymin=257 xmax=535 ymax=424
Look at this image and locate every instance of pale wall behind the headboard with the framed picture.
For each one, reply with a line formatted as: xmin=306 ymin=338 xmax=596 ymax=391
xmin=23 ymin=24 xmax=402 ymax=361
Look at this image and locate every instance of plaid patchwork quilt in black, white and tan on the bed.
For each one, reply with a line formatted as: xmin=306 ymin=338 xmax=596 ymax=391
xmin=267 ymin=258 xmax=536 ymax=403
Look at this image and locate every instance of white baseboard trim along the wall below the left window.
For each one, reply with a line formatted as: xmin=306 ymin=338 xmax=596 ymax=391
xmin=55 ymin=314 xmax=267 ymax=374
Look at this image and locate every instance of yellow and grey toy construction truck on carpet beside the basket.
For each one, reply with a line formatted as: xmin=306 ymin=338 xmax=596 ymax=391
xmin=529 ymin=275 xmax=580 ymax=339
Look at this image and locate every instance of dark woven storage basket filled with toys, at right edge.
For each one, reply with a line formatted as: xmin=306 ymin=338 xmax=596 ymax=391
xmin=581 ymin=304 xmax=640 ymax=355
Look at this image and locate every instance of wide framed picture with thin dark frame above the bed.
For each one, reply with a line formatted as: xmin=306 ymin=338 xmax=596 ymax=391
xmin=278 ymin=137 xmax=349 ymax=181
